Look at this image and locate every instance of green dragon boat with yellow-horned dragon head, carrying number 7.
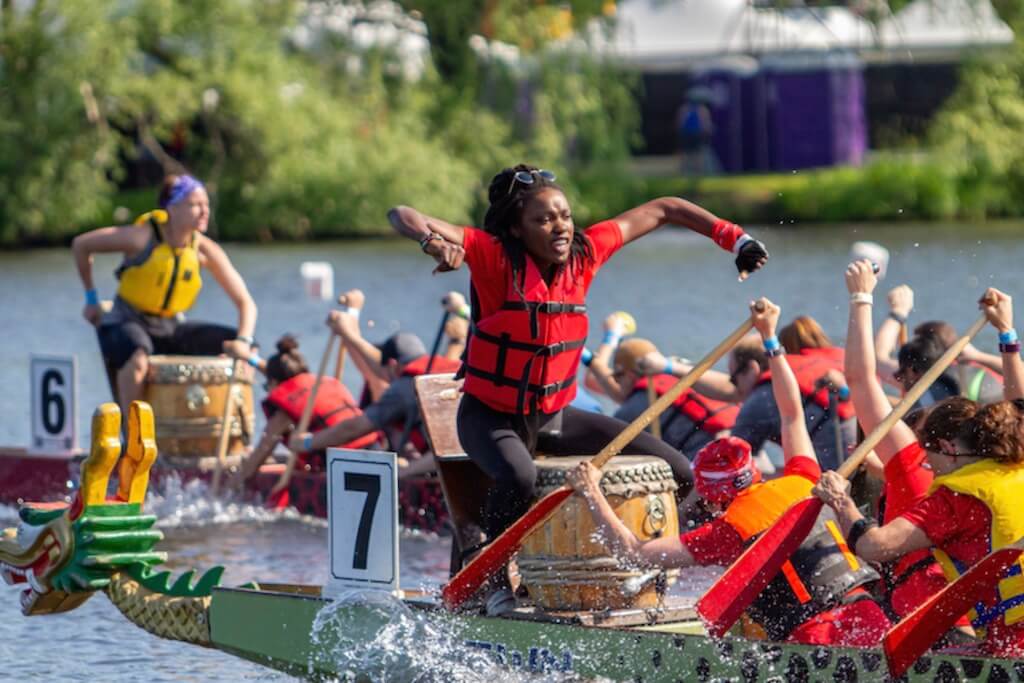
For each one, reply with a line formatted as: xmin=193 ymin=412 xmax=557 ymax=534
xmin=0 ymin=401 xmax=1024 ymax=682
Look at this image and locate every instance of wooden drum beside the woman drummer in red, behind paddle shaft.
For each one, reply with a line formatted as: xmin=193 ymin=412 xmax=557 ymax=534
xmin=518 ymin=456 xmax=679 ymax=610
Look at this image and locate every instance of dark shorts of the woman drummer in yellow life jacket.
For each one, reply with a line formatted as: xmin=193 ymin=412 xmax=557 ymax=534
xmin=96 ymin=319 xmax=238 ymax=370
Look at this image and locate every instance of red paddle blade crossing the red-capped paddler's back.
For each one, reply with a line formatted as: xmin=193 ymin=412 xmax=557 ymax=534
xmin=696 ymin=498 xmax=821 ymax=638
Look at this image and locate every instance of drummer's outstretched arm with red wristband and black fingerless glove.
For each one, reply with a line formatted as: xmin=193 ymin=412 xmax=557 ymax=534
xmin=615 ymin=197 xmax=768 ymax=280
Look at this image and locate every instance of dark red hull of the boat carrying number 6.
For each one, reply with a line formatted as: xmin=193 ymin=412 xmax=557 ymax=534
xmin=0 ymin=447 xmax=449 ymax=532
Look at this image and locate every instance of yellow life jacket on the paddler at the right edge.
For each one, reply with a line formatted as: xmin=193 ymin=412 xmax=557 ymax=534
xmin=931 ymin=459 xmax=1024 ymax=629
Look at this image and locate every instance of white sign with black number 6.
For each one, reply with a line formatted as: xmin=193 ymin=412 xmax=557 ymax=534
xmin=29 ymin=354 xmax=78 ymax=455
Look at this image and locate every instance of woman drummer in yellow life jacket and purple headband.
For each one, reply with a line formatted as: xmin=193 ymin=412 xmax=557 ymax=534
xmin=72 ymin=175 xmax=256 ymax=415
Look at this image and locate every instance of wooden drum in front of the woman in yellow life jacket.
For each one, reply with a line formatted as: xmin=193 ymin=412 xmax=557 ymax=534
xmin=145 ymin=355 xmax=255 ymax=469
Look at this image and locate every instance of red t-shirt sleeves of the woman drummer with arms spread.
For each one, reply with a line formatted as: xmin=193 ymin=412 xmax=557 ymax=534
xmin=462 ymin=220 xmax=623 ymax=317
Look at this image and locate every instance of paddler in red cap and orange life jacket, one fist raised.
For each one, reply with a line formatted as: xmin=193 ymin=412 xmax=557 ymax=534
xmin=568 ymin=299 xmax=890 ymax=647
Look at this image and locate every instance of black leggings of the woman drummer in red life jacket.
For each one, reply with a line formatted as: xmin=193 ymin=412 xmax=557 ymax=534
xmin=459 ymin=394 xmax=693 ymax=539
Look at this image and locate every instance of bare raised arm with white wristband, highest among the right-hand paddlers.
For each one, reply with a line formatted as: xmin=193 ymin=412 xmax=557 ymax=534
xmin=844 ymin=260 xmax=916 ymax=464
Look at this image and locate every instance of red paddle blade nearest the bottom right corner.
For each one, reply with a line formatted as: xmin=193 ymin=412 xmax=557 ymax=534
xmin=882 ymin=547 xmax=1022 ymax=678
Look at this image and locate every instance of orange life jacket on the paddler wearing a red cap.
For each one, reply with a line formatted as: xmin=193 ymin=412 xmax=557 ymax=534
xmin=723 ymin=475 xmax=880 ymax=640
